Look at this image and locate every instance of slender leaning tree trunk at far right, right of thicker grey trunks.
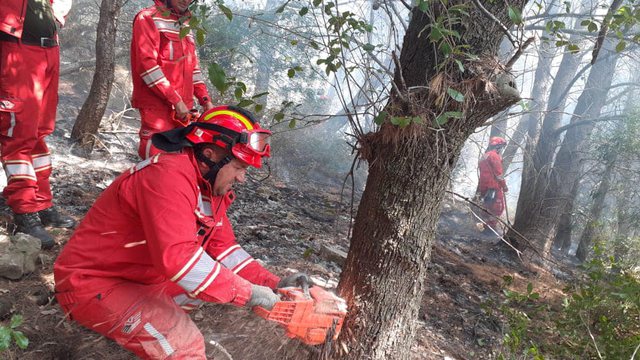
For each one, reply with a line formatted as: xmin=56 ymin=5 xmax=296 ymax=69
xmin=576 ymin=152 xmax=618 ymax=262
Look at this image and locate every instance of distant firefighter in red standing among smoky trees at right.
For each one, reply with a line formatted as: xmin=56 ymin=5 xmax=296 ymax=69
xmin=476 ymin=136 xmax=508 ymax=234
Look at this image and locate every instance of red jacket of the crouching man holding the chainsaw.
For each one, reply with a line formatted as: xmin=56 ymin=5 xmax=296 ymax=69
xmin=54 ymin=150 xmax=280 ymax=305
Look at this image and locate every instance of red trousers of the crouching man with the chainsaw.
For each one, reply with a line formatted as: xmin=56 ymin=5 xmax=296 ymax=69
xmin=57 ymin=283 xmax=206 ymax=359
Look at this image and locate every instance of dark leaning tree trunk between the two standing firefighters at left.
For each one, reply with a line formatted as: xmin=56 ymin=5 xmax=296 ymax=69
xmin=71 ymin=0 xmax=124 ymax=154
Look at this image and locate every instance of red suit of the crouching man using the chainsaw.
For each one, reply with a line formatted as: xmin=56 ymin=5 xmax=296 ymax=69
xmin=54 ymin=149 xmax=280 ymax=359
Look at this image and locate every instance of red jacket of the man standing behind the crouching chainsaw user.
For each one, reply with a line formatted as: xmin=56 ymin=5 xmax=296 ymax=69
xmin=131 ymin=0 xmax=209 ymax=108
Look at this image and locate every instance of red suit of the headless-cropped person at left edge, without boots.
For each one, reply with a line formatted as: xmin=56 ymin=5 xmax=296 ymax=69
xmin=0 ymin=0 xmax=71 ymax=214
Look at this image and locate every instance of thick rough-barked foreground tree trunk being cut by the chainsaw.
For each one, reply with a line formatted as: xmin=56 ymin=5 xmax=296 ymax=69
xmin=333 ymin=0 xmax=525 ymax=360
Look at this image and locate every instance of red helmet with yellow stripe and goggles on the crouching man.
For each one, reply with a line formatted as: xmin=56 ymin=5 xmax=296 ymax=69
xmin=186 ymin=106 xmax=271 ymax=168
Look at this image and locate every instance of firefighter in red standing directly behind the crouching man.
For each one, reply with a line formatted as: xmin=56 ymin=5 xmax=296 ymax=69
xmin=131 ymin=0 xmax=213 ymax=159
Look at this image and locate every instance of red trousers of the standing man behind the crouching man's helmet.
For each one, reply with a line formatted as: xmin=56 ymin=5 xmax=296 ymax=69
xmin=138 ymin=106 xmax=178 ymax=159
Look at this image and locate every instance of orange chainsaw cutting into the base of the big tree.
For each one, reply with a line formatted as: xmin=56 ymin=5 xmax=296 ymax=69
xmin=253 ymin=285 xmax=347 ymax=345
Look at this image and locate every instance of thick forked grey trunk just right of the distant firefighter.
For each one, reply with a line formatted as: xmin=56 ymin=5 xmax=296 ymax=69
xmin=507 ymin=37 xmax=618 ymax=257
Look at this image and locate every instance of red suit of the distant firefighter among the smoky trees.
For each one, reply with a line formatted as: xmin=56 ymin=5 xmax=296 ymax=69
xmin=477 ymin=149 xmax=506 ymax=229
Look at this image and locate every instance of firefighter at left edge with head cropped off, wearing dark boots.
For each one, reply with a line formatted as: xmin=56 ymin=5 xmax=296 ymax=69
xmin=0 ymin=0 xmax=75 ymax=248
